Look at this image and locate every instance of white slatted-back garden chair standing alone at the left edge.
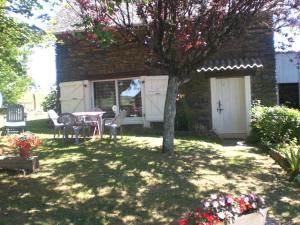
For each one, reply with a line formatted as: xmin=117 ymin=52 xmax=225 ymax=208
xmin=4 ymin=104 xmax=26 ymax=134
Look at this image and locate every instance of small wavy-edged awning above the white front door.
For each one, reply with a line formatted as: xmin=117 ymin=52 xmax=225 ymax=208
xmin=197 ymin=58 xmax=263 ymax=73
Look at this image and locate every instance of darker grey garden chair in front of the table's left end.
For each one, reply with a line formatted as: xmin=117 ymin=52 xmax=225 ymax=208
xmin=57 ymin=113 xmax=82 ymax=144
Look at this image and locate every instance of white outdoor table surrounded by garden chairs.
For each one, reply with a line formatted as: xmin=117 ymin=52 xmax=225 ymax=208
xmin=72 ymin=111 xmax=106 ymax=136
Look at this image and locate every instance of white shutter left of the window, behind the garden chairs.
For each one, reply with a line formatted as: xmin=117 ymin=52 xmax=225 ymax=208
xmin=59 ymin=81 xmax=91 ymax=113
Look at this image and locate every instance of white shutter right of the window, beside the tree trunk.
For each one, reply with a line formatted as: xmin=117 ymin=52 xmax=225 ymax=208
xmin=143 ymin=76 xmax=168 ymax=122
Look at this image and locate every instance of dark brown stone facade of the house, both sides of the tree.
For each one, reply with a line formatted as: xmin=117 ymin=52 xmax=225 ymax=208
xmin=56 ymin=19 xmax=277 ymax=134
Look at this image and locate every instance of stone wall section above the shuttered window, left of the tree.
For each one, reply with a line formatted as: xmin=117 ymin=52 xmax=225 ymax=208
xmin=56 ymin=40 xmax=161 ymax=82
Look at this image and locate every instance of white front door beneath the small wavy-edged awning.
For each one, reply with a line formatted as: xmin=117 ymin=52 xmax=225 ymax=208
xmin=211 ymin=77 xmax=248 ymax=138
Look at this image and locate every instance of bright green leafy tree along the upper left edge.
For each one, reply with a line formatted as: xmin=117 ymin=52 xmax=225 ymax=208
xmin=0 ymin=0 xmax=59 ymax=103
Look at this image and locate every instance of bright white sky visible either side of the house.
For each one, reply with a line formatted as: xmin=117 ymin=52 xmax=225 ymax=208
xmin=28 ymin=16 xmax=300 ymax=91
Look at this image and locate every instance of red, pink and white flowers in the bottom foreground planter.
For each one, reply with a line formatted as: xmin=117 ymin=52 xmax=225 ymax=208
xmin=179 ymin=193 xmax=266 ymax=225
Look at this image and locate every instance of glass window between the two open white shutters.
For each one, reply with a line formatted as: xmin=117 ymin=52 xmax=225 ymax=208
xmin=94 ymin=79 xmax=142 ymax=117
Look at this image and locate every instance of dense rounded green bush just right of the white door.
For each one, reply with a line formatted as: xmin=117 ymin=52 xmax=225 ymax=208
xmin=248 ymin=104 xmax=300 ymax=146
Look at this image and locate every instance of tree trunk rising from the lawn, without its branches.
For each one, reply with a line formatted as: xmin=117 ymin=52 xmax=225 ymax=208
xmin=162 ymin=76 xmax=180 ymax=154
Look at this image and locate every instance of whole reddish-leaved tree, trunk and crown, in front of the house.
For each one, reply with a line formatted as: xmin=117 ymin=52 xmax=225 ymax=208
xmin=69 ymin=0 xmax=300 ymax=153
